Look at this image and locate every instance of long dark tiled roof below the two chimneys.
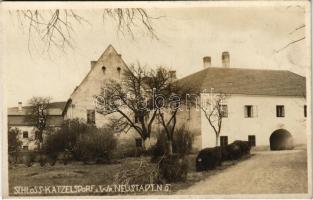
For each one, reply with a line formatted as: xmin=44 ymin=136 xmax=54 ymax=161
xmin=178 ymin=67 xmax=306 ymax=97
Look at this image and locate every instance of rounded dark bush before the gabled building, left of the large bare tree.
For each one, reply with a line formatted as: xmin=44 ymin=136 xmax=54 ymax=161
xmin=73 ymin=128 xmax=117 ymax=163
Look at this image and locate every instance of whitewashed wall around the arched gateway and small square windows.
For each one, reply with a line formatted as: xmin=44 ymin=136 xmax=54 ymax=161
xmin=201 ymin=94 xmax=309 ymax=148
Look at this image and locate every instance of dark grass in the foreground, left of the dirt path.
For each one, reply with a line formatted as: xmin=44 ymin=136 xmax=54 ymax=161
xmin=9 ymin=154 xmax=252 ymax=195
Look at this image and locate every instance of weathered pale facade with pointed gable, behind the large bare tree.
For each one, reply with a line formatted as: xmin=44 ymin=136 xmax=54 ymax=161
xmin=64 ymin=45 xmax=140 ymax=146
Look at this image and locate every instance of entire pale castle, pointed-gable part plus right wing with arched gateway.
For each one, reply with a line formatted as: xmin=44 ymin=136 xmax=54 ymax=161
xmin=64 ymin=45 xmax=306 ymax=149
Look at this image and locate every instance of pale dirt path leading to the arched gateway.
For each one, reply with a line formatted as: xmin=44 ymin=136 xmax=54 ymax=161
xmin=177 ymin=149 xmax=308 ymax=195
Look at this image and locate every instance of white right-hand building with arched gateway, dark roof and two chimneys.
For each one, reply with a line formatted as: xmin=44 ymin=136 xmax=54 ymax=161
xmin=180 ymin=52 xmax=307 ymax=148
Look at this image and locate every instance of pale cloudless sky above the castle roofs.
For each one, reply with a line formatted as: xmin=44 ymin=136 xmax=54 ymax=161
xmin=2 ymin=4 xmax=310 ymax=106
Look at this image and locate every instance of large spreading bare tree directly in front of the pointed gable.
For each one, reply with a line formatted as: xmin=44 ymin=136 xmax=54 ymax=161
xmin=96 ymin=64 xmax=157 ymax=147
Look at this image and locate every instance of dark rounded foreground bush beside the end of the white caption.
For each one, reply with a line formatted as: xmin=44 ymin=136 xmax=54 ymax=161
xmin=159 ymin=154 xmax=188 ymax=183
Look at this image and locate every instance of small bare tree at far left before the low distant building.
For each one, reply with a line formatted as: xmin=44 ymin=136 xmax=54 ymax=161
xmin=29 ymin=97 xmax=51 ymax=150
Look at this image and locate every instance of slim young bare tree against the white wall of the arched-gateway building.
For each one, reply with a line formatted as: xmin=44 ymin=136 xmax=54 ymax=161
xmin=198 ymin=93 xmax=229 ymax=146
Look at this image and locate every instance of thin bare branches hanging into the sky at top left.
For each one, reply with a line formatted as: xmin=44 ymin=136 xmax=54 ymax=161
xmin=10 ymin=8 xmax=160 ymax=52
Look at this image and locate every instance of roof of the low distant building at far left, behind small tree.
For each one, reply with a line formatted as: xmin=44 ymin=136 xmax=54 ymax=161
xmin=8 ymin=101 xmax=66 ymax=116
